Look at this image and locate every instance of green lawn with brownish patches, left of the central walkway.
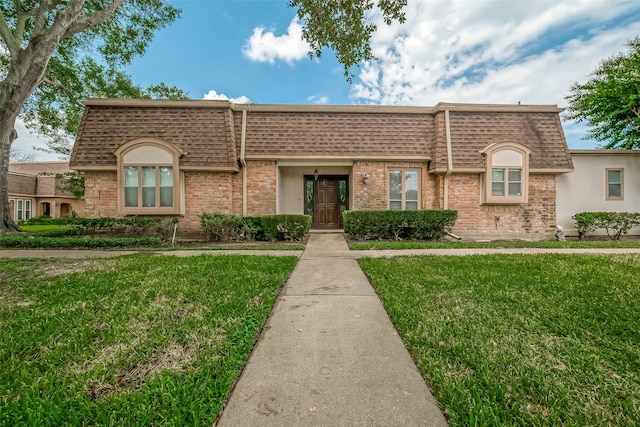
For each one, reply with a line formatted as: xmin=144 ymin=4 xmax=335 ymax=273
xmin=0 ymin=255 xmax=297 ymax=426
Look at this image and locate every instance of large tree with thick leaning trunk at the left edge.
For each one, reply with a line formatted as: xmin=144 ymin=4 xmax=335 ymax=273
xmin=0 ymin=0 xmax=179 ymax=234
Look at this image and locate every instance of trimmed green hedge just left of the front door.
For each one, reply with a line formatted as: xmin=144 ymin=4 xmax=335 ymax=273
xmin=200 ymin=213 xmax=311 ymax=242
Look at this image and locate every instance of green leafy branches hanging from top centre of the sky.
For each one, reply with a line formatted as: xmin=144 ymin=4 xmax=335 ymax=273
xmin=288 ymin=0 xmax=407 ymax=81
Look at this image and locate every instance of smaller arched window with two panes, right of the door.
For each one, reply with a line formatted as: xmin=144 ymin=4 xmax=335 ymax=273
xmin=481 ymin=142 xmax=531 ymax=204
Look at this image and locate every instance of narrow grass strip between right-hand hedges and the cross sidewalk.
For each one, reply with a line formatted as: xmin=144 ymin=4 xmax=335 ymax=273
xmin=349 ymin=239 xmax=640 ymax=250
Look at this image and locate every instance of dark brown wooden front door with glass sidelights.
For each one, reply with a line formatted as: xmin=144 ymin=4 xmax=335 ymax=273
xmin=305 ymin=176 xmax=347 ymax=229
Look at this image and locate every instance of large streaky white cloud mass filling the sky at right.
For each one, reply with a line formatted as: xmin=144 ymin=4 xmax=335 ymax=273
xmin=351 ymin=0 xmax=640 ymax=147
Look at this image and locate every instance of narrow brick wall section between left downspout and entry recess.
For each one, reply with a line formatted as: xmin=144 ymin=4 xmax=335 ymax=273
xmin=240 ymin=161 xmax=278 ymax=216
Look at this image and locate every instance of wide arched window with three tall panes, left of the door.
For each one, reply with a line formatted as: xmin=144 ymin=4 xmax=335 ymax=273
xmin=114 ymin=138 xmax=182 ymax=215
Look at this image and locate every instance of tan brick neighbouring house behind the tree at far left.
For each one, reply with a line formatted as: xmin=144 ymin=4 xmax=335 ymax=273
xmin=8 ymin=161 xmax=84 ymax=221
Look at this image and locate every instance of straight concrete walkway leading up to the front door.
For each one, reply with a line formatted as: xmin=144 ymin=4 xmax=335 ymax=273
xmin=218 ymin=234 xmax=446 ymax=427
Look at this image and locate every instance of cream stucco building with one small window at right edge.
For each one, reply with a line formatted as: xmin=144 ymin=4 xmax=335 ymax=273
xmin=556 ymin=150 xmax=640 ymax=236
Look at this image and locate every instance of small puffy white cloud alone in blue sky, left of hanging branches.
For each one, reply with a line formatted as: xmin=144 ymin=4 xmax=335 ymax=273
xmin=242 ymin=18 xmax=309 ymax=64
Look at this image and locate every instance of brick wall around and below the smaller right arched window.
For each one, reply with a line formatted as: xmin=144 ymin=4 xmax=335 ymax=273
xmin=449 ymin=174 xmax=556 ymax=240
